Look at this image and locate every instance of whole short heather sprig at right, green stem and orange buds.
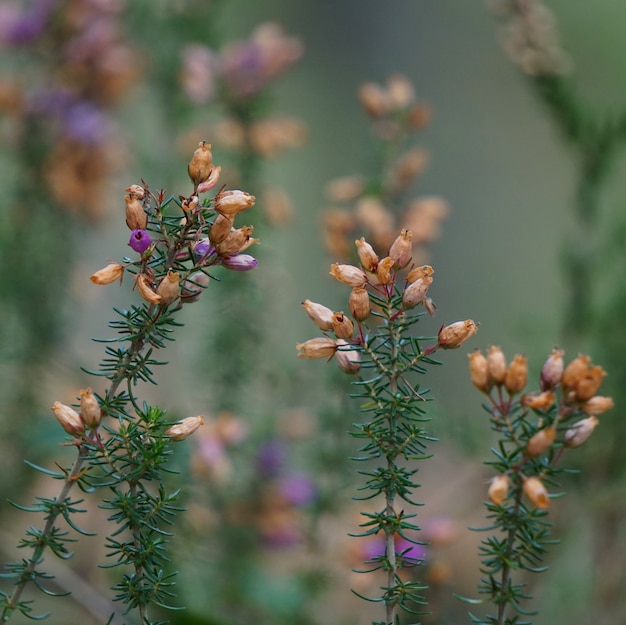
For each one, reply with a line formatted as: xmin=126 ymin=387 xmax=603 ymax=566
xmin=469 ymin=346 xmax=613 ymax=623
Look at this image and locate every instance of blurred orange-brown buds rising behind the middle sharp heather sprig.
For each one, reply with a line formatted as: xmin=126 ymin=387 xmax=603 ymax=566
xmin=324 ymin=74 xmax=449 ymax=262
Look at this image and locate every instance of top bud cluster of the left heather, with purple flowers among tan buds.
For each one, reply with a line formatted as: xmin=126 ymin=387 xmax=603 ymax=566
xmin=91 ymin=141 xmax=258 ymax=306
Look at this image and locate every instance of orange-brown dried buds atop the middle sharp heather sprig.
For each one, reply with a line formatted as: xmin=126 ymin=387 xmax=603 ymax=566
xmin=296 ymin=230 xmax=478 ymax=373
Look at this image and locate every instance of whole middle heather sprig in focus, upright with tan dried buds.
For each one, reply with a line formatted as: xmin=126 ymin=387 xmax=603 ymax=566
xmin=297 ymin=230 xmax=477 ymax=624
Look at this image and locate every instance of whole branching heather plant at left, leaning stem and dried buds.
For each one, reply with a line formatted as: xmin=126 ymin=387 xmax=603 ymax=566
xmin=0 ymin=141 xmax=257 ymax=623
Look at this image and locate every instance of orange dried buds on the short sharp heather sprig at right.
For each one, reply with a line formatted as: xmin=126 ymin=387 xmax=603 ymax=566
xmin=469 ymin=346 xmax=613 ymax=509
